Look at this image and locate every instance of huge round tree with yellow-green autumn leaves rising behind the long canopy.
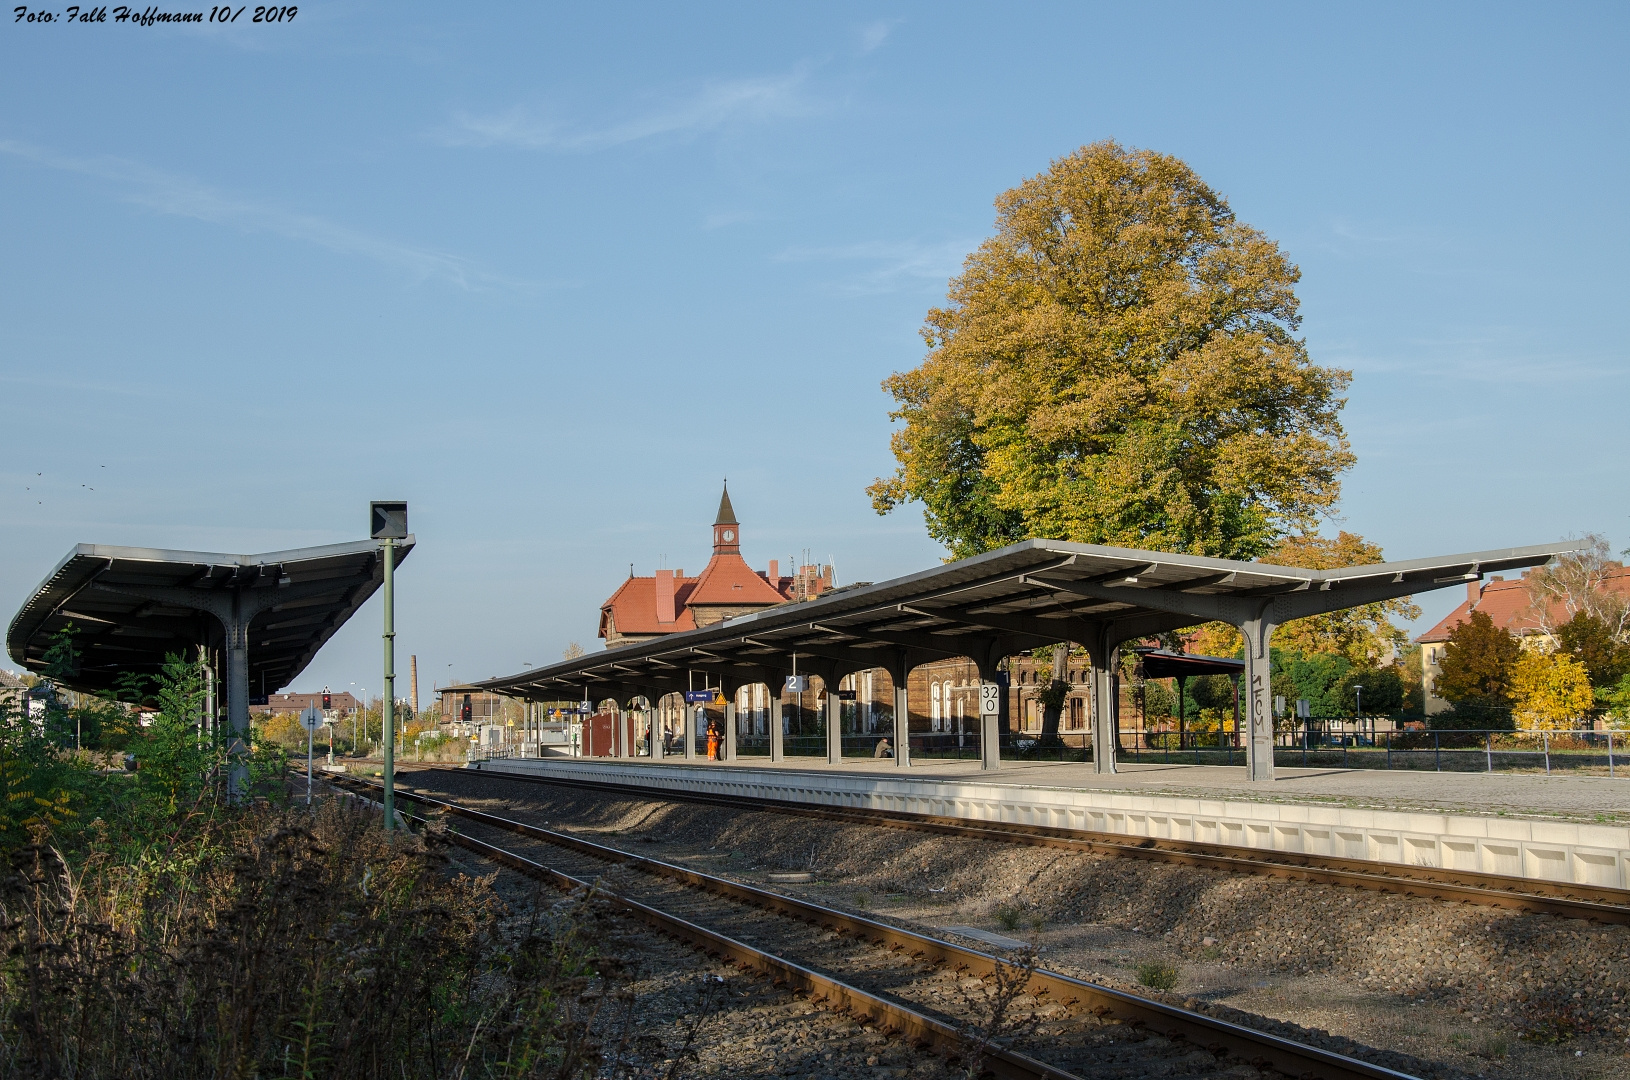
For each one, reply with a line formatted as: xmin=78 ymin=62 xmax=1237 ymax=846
xmin=870 ymin=142 xmax=1353 ymax=559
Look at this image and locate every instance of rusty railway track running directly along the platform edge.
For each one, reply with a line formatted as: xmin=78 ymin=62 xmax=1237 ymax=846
xmin=438 ymin=769 xmax=1630 ymax=924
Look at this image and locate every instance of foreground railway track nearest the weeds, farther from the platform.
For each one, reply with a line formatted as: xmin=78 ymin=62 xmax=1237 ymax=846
xmin=334 ymin=777 xmax=1408 ymax=1080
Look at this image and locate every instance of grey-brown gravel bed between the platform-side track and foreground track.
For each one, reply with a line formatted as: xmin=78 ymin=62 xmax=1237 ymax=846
xmin=401 ymin=770 xmax=1630 ymax=1078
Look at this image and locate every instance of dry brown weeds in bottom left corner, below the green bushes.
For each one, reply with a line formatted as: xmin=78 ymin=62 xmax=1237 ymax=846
xmin=0 ymin=800 xmax=624 ymax=1080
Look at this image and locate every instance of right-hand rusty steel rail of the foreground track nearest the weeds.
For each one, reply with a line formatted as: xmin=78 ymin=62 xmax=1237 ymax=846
xmin=347 ymin=777 xmax=1413 ymax=1080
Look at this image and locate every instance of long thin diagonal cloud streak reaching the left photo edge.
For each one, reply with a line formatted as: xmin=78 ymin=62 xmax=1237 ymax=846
xmin=0 ymin=138 xmax=522 ymax=290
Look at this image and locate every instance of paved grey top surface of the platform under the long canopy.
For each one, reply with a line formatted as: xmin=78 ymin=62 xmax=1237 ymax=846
xmin=502 ymin=757 xmax=1630 ymax=823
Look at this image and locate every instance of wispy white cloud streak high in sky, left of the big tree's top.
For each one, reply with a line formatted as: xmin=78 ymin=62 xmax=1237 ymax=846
xmin=438 ymin=70 xmax=815 ymax=153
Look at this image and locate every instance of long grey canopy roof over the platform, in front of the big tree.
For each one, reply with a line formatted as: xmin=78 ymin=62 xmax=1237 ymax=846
xmin=478 ymin=539 xmax=1578 ymax=700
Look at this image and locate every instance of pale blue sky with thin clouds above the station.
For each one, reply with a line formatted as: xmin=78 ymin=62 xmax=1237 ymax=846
xmin=0 ymin=3 xmax=1630 ymax=691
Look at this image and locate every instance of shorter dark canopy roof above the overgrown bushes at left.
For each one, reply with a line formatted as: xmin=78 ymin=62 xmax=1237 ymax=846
xmin=7 ymin=536 xmax=414 ymax=696
